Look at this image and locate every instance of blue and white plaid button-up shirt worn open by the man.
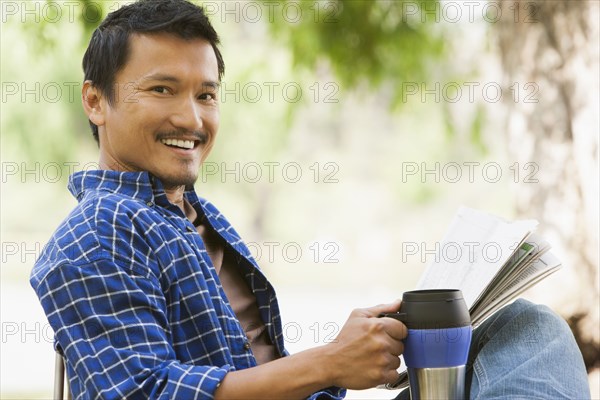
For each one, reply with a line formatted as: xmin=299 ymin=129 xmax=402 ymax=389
xmin=31 ymin=171 xmax=344 ymax=400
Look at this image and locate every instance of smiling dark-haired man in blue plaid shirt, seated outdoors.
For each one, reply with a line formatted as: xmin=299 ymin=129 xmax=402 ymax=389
xmin=31 ymin=0 xmax=585 ymax=399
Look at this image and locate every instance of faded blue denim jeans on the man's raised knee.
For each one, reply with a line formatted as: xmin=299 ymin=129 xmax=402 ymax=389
xmin=396 ymin=300 xmax=590 ymax=399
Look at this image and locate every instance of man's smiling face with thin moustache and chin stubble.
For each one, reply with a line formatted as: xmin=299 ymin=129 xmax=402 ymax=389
xmin=99 ymin=34 xmax=219 ymax=188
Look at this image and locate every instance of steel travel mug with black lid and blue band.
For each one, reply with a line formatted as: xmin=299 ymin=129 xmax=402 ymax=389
xmin=382 ymin=289 xmax=472 ymax=400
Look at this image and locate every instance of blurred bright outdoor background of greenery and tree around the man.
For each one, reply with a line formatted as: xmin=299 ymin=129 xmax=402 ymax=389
xmin=0 ymin=0 xmax=600 ymax=399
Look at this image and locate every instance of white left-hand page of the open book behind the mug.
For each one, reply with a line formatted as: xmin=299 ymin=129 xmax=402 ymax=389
xmin=417 ymin=207 xmax=538 ymax=309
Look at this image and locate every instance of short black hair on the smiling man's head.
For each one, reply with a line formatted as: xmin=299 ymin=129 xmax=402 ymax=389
xmin=82 ymin=0 xmax=225 ymax=142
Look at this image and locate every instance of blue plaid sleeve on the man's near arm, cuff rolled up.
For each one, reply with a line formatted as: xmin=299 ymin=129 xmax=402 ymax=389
xmin=36 ymin=260 xmax=230 ymax=400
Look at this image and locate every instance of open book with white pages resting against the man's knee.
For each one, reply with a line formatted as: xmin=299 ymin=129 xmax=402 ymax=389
xmin=385 ymin=207 xmax=561 ymax=389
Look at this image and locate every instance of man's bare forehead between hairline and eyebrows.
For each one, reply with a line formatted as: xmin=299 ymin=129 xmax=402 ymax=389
xmin=119 ymin=33 xmax=219 ymax=82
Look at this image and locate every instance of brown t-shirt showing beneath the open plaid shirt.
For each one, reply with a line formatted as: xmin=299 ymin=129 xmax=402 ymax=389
xmin=194 ymin=218 xmax=278 ymax=365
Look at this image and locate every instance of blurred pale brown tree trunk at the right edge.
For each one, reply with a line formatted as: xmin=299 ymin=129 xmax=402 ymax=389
xmin=497 ymin=0 xmax=600 ymax=371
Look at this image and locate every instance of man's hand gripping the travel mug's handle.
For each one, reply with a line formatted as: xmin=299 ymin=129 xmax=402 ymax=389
xmin=324 ymin=301 xmax=407 ymax=390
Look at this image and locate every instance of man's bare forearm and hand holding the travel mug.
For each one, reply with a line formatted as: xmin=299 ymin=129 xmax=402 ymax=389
xmin=215 ymin=301 xmax=407 ymax=400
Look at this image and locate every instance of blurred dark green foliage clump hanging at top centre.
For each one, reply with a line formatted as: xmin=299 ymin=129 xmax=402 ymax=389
xmin=265 ymin=0 xmax=444 ymax=105
